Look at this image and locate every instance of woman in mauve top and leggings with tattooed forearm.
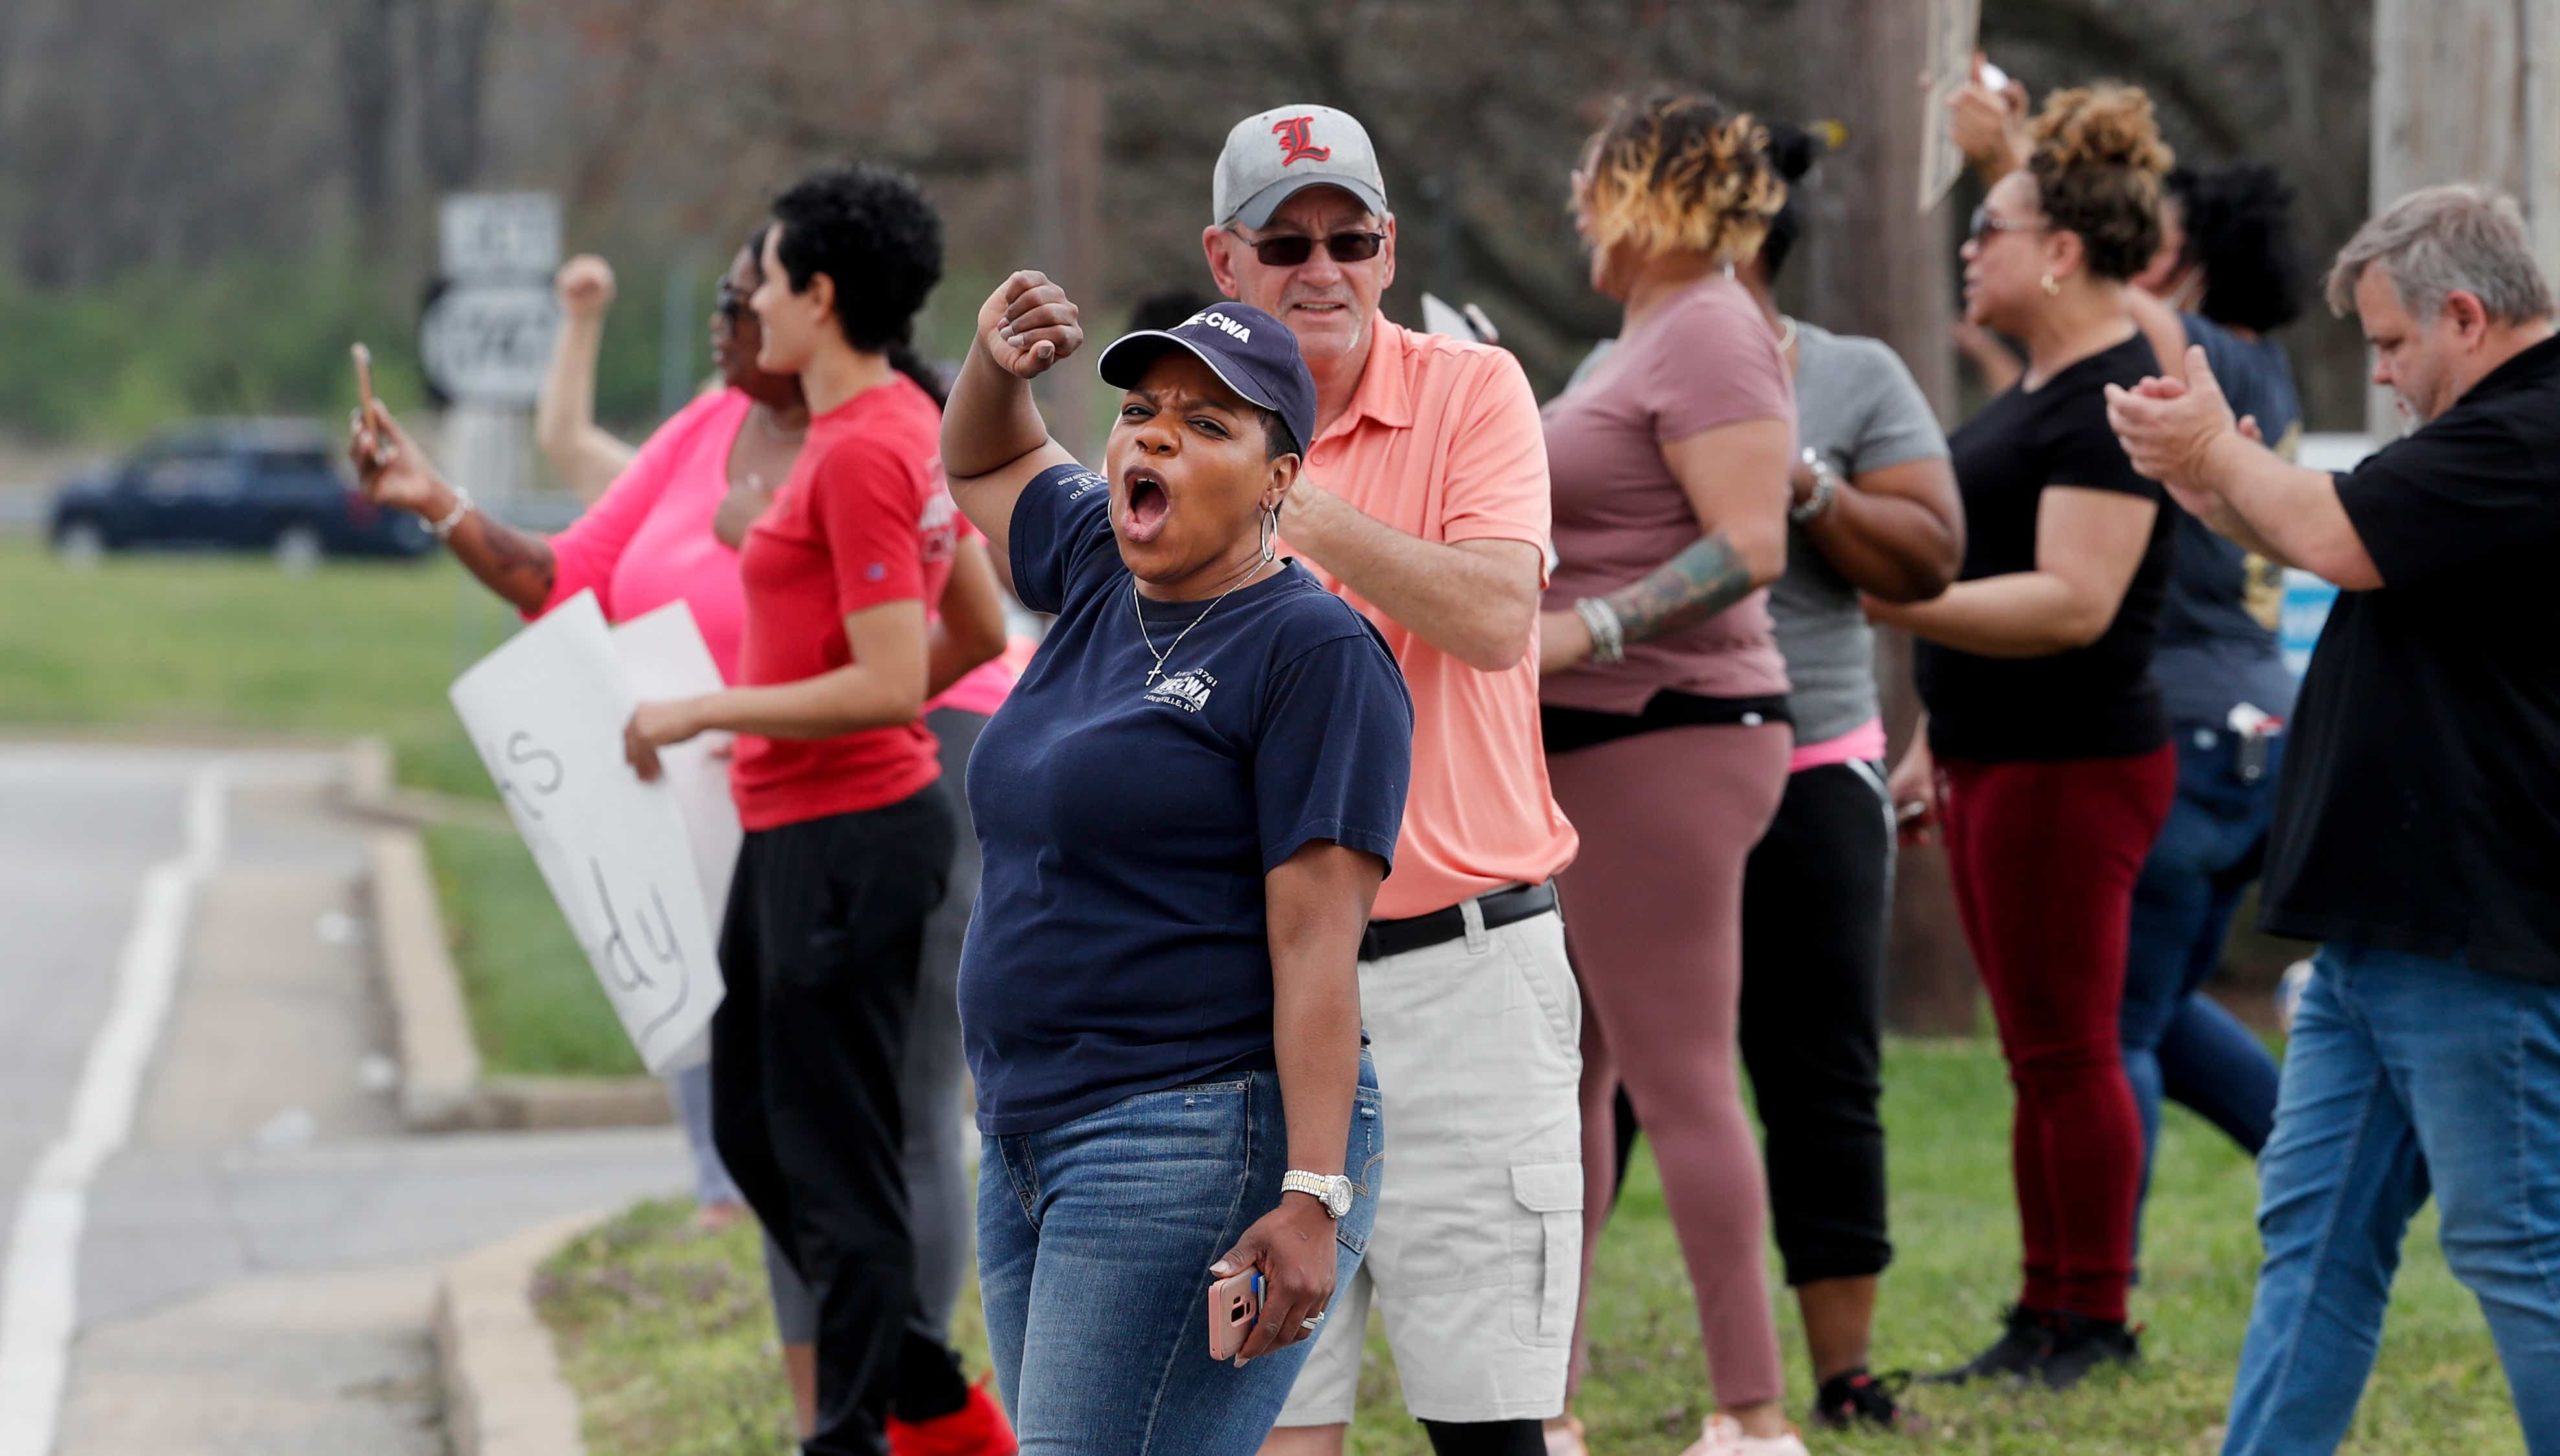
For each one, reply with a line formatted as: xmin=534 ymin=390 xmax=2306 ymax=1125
xmin=1539 ymin=95 xmax=1805 ymax=1456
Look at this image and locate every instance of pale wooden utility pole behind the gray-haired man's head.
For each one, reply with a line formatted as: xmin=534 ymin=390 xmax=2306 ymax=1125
xmin=2368 ymin=0 xmax=2560 ymax=440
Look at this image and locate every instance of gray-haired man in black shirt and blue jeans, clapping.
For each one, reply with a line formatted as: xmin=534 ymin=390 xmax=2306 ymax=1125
xmin=2109 ymin=187 xmax=2560 ymax=1453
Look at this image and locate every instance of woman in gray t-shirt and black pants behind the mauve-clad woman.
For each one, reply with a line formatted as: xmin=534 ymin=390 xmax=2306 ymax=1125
xmin=1618 ymin=123 xmax=1964 ymax=1428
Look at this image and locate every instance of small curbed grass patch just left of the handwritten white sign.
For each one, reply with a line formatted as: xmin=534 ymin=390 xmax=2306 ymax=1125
xmin=428 ymin=824 xmax=643 ymax=1077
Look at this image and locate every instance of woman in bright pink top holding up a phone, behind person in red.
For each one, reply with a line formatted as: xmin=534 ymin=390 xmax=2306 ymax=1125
xmin=356 ymin=230 xmax=1014 ymax=1430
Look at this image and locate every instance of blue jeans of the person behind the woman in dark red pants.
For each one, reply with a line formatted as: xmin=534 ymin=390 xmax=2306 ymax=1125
xmin=2117 ymin=724 xmax=2284 ymax=1233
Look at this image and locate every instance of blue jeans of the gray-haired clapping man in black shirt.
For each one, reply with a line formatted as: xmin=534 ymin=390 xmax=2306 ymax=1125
xmin=2222 ymin=944 xmax=2560 ymax=1456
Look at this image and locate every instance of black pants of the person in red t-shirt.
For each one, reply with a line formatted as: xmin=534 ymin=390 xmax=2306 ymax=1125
xmin=712 ymin=783 xmax=960 ymax=1456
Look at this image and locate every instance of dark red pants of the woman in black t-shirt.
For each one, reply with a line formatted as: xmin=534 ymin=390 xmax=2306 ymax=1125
xmin=1938 ymin=745 xmax=2179 ymax=1320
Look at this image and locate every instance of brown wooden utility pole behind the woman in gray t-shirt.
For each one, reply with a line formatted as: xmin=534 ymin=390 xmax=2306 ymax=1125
xmin=1787 ymin=0 xmax=1979 ymax=1034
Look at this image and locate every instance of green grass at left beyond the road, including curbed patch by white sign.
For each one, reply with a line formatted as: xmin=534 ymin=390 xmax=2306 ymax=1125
xmin=0 ymin=537 xmax=640 ymax=1075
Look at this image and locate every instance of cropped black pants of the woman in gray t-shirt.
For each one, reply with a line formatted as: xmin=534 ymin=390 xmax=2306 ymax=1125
xmin=1618 ymin=763 xmax=1894 ymax=1287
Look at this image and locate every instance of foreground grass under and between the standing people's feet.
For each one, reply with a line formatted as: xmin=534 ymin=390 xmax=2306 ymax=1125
xmin=540 ymin=1041 xmax=2524 ymax=1456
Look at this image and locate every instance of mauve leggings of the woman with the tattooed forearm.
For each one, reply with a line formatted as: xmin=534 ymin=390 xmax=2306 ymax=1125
xmin=1546 ymin=724 xmax=1795 ymax=1410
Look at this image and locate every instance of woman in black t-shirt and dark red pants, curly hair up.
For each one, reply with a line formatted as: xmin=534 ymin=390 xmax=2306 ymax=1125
xmin=1869 ymin=87 xmax=2176 ymax=1387
